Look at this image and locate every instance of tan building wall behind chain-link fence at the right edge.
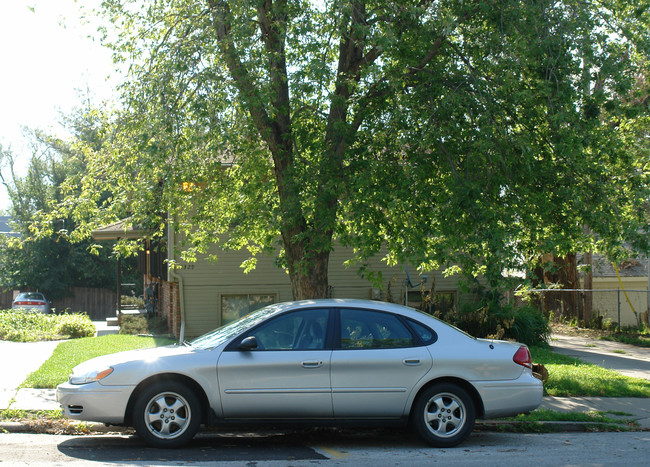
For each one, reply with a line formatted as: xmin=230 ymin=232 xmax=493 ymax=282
xmin=593 ymin=255 xmax=650 ymax=326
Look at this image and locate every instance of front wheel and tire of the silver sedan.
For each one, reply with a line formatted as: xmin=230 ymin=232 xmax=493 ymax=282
xmin=133 ymin=381 xmax=201 ymax=448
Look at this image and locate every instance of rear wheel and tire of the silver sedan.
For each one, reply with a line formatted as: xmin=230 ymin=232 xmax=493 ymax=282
xmin=411 ymin=383 xmax=476 ymax=448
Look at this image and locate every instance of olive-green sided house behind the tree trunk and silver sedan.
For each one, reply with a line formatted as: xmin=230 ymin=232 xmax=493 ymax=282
xmin=93 ymin=223 xmax=472 ymax=338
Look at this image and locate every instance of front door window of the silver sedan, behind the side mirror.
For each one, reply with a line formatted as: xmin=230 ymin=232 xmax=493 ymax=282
xmin=247 ymin=309 xmax=329 ymax=350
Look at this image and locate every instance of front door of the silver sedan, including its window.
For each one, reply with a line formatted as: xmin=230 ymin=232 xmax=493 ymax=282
xmin=217 ymin=308 xmax=332 ymax=419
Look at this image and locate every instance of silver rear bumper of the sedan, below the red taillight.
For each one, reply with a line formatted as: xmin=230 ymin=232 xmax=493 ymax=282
xmin=472 ymin=370 xmax=544 ymax=418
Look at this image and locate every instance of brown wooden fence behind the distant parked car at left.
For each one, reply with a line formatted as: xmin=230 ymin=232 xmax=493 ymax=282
xmin=0 ymin=287 xmax=116 ymax=321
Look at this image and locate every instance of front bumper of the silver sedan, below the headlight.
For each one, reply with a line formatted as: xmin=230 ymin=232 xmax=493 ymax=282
xmin=56 ymin=382 xmax=135 ymax=425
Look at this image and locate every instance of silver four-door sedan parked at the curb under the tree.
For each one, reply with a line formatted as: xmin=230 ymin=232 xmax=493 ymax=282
xmin=57 ymin=299 xmax=542 ymax=447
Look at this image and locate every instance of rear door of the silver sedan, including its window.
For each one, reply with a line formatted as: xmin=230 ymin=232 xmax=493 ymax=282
xmin=332 ymin=308 xmax=433 ymax=418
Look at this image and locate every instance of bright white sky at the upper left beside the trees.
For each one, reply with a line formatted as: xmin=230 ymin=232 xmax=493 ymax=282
xmin=0 ymin=0 xmax=116 ymax=210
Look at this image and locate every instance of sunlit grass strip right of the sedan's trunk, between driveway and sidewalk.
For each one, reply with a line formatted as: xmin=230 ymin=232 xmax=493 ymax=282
xmin=530 ymin=347 xmax=650 ymax=397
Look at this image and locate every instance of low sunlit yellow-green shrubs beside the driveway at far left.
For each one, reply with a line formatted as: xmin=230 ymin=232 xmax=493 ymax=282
xmin=0 ymin=310 xmax=95 ymax=342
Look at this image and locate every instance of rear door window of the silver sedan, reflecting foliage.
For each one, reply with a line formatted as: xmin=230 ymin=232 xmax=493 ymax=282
xmin=341 ymin=309 xmax=414 ymax=349
